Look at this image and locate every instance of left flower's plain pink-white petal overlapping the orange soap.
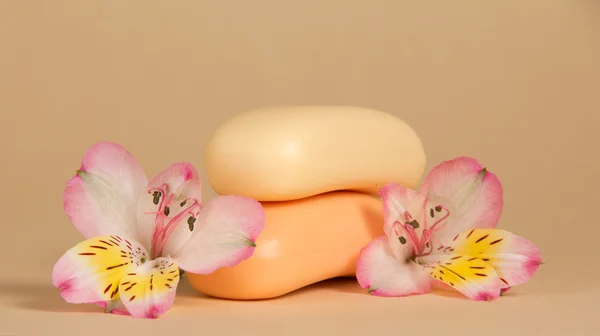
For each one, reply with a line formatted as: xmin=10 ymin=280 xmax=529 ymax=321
xmin=165 ymin=196 xmax=265 ymax=274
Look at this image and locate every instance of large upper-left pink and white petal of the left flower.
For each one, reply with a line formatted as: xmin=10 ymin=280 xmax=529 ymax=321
xmin=63 ymin=142 xmax=147 ymax=238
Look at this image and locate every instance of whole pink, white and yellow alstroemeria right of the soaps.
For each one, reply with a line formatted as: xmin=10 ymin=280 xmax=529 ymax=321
xmin=356 ymin=157 xmax=542 ymax=301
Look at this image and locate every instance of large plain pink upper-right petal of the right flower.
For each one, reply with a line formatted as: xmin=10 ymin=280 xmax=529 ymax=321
xmin=420 ymin=157 xmax=504 ymax=243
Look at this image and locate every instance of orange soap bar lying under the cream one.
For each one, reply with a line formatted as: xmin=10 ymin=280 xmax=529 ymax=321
xmin=186 ymin=191 xmax=383 ymax=300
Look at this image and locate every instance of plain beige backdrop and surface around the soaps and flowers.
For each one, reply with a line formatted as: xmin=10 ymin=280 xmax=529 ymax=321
xmin=0 ymin=0 xmax=600 ymax=335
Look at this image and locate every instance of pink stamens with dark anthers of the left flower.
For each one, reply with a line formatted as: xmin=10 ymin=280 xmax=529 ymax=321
xmin=148 ymin=183 xmax=202 ymax=259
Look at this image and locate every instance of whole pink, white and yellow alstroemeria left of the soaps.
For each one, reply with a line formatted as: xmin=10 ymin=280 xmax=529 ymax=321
xmin=52 ymin=142 xmax=264 ymax=318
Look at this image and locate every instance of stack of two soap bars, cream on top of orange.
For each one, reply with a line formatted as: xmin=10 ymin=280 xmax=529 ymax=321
xmin=188 ymin=106 xmax=425 ymax=299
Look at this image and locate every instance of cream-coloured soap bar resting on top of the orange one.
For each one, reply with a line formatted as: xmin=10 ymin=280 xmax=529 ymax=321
xmin=204 ymin=106 xmax=425 ymax=201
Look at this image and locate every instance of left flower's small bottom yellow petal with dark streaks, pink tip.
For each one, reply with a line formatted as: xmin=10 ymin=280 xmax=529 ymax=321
xmin=119 ymin=258 xmax=179 ymax=319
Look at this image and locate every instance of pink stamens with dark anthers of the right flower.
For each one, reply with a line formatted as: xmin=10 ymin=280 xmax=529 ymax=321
xmin=396 ymin=202 xmax=450 ymax=257
